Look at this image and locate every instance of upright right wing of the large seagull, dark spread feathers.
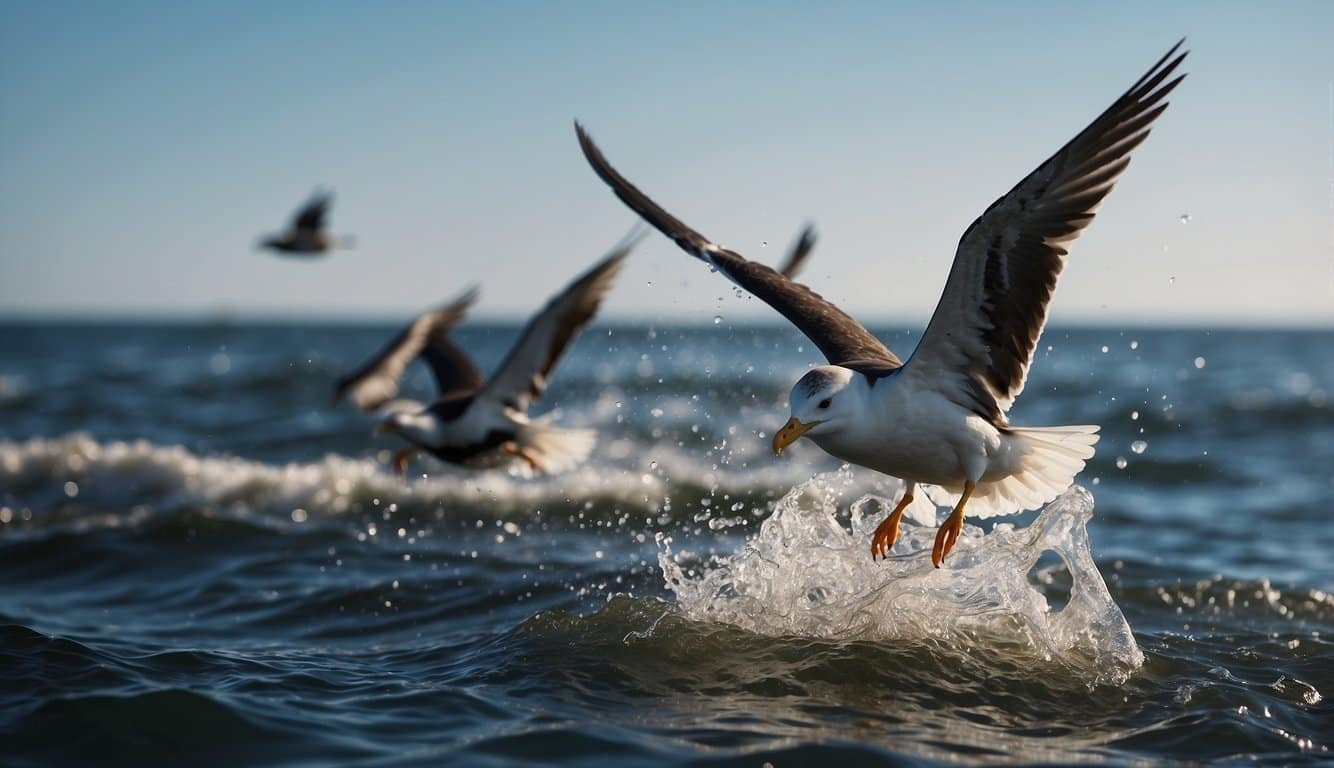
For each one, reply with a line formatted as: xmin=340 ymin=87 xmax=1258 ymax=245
xmin=904 ymin=40 xmax=1186 ymax=424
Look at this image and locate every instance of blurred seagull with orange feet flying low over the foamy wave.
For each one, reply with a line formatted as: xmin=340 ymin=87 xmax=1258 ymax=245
xmin=370 ymin=233 xmax=642 ymax=475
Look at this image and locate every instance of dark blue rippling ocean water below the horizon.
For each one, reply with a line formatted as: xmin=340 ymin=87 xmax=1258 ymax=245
xmin=0 ymin=321 xmax=1334 ymax=767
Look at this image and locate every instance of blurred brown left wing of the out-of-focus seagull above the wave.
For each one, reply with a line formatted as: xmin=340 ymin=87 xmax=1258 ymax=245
xmin=334 ymin=288 xmax=482 ymax=411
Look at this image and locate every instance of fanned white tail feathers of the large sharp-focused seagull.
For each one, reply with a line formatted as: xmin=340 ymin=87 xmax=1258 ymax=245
xmin=927 ymin=424 xmax=1098 ymax=519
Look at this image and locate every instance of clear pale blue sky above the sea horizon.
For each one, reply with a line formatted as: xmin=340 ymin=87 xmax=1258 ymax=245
xmin=0 ymin=1 xmax=1334 ymax=324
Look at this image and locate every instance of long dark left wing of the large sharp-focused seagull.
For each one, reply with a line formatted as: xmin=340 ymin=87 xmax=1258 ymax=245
xmin=575 ymin=123 xmax=902 ymax=372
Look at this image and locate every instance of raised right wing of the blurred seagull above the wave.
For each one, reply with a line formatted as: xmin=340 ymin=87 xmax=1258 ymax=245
xmin=479 ymin=237 xmax=639 ymax=411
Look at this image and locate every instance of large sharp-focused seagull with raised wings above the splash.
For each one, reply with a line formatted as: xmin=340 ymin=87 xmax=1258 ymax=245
xmin=575 ymin=40 xmax=1186 ymax=568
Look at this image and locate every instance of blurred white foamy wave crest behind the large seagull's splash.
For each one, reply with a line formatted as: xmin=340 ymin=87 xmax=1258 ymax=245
xmin=0 ymin=433 xmax=882 ymax=525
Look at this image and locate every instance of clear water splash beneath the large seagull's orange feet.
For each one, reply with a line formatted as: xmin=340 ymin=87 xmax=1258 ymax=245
xmin=659 ymin=476 xmax=1143 ymax=685
